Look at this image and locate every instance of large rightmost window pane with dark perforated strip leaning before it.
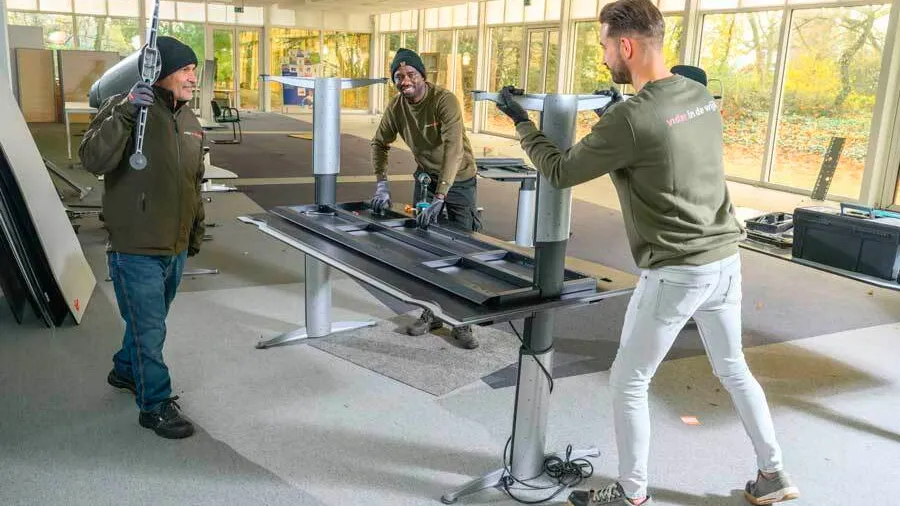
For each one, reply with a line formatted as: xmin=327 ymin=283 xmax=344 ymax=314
xmin=770 ymin=4 xmax=890 ymax=198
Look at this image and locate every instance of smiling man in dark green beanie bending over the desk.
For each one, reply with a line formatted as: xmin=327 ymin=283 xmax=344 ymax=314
xmin=372 ymin=48 xmax=481 ymax=349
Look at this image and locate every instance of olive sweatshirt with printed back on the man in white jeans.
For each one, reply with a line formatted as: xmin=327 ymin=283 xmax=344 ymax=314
xmin=516 ymin=75 xmax=744 ymax=269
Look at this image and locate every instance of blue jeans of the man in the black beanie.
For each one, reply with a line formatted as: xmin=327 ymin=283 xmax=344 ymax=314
xmin=107 ymin=251 xmax=187 ymax=411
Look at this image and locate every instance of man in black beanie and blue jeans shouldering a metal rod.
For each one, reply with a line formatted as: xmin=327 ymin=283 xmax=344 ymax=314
xmin=78 ymin=37 xmax=204 ymax=439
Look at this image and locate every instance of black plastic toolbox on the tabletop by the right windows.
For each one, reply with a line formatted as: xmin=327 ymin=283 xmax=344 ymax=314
xmin=792 ymin=207 xmax=900 ymax=282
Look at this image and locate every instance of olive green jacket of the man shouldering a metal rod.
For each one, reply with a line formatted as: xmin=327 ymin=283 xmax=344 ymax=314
xmin=78 ymin=87 xmax=204 ymax=256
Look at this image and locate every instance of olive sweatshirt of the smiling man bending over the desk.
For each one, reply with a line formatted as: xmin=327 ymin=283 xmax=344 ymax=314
xmin=372 ymin=83 xmax=475 ymax=195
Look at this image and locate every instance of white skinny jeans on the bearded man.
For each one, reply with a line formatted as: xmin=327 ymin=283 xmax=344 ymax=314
xmin=610 ymin=254 xmax=783 ymax=498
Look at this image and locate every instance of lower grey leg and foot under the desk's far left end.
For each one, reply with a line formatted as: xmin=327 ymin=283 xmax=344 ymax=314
xmin=256 ymin=255 xmax=375 ymax=349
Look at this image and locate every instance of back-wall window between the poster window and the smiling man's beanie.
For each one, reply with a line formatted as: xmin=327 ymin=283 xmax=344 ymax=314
xmin=322 ymin=33 xmax=371 ymax=109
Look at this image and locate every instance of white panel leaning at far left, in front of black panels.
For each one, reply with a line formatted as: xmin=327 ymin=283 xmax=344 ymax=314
xmin=0 ymin=73 xmax=97 ymax=323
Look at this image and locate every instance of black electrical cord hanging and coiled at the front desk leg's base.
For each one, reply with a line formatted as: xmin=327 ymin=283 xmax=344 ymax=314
xmin=500 ymin=321 xmax=594 ymax=504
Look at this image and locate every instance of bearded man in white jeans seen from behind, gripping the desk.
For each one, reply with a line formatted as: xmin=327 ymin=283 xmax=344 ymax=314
xmin=498 ymin=0 xmax=799 ymax=506
